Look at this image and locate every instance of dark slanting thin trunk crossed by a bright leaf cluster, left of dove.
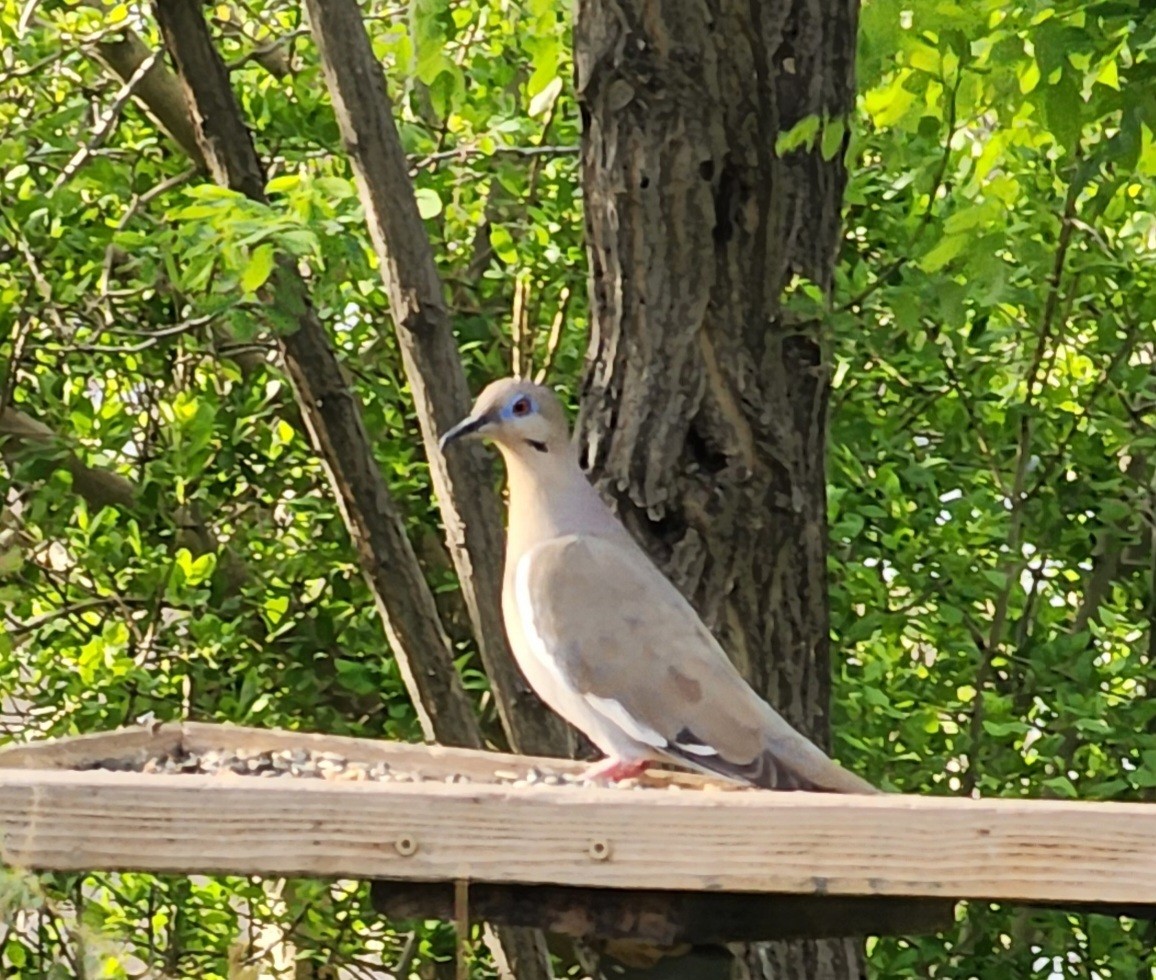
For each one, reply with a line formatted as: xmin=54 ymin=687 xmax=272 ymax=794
xmin=154 ymin=0 xmax=482 ymax=745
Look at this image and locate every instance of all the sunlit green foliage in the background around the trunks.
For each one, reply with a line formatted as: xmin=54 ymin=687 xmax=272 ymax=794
xmin=0 ymin=0 xmax=1156 ymax=980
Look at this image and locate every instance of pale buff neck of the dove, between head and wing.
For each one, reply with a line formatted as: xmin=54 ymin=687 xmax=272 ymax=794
xmin=501 ymin=445 xmax=629 ymax=569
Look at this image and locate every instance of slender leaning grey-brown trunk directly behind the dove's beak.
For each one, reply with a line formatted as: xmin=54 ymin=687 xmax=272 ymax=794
xmin=306 ymin=0 xmax=568 ymax=755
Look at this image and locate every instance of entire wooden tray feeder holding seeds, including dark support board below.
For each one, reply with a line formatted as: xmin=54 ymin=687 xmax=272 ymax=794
xmin=0 ymin=723 xmax=1156 ymax=944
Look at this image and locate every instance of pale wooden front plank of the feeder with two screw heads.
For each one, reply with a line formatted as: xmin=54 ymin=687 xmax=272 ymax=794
xmin=0 ymin=770 xmax=1156 ymax=904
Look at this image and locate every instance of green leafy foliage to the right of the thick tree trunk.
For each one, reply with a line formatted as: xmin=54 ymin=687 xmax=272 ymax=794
xmin=831 ymin=0 xmax=1156 ymax=978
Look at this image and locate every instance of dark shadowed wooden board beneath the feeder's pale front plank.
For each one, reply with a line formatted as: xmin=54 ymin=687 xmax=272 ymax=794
xmin=372 ymin=881 xmax=955 ymax=948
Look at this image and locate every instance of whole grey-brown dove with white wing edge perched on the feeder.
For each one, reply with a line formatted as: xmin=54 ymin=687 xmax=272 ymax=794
xmin=442 ymin=378 xmax=877 ymax=793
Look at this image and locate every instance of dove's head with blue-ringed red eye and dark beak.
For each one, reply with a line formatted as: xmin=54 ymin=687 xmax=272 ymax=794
xmin=439 ymin=378 xmax=570 ymax=455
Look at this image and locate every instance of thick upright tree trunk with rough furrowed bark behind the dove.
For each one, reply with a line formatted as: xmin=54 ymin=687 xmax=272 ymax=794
xmin=575 ymin=0 xmax=860 ymax=980
